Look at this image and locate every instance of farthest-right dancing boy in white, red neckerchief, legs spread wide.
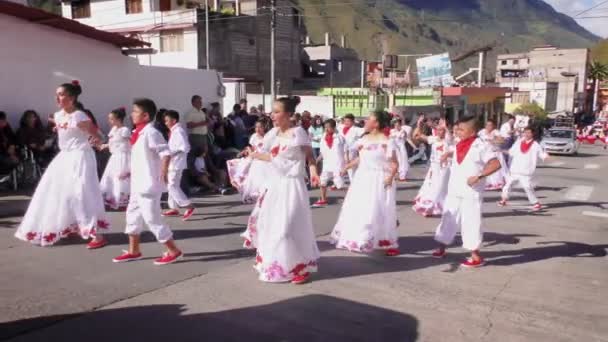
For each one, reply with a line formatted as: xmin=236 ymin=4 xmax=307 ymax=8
xmin=498 ymin=127 xmax=549 ymax=211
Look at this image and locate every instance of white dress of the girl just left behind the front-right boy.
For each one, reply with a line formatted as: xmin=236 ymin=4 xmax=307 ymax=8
xmin=412 ymin=137 xmax=450 ymax=216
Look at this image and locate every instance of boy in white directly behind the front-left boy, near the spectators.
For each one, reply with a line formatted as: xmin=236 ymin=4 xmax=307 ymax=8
xmin=163 ymin=110 xmax=194 ymax=221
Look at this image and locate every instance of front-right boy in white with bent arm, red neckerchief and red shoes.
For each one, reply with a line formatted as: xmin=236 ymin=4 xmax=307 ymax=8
xmin=433 ymin=116 xmax=500 ymax=267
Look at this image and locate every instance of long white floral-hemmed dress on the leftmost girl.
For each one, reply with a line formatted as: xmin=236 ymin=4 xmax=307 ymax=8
xmin=15 ymin=111 xmax=110 ymax=246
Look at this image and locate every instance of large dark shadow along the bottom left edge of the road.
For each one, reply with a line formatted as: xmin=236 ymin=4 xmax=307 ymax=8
xmin=0 ymin=296 xmax=418 ymax=342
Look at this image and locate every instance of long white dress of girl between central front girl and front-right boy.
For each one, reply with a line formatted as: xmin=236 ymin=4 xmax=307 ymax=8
xmin=331 ymin=137 xmax=399 ymax=253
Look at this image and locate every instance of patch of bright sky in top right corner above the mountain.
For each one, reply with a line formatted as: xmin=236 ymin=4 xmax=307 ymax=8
xmin=545 ymin=0 xmax=608 ymax=38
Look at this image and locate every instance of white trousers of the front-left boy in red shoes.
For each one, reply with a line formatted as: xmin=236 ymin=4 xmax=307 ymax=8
xmin=125 ymin=193 xmax=173 ymax=243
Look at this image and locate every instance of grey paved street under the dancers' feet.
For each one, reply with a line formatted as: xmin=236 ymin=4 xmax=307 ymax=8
xmin=0 ymin=146 xmax=608 ymax=342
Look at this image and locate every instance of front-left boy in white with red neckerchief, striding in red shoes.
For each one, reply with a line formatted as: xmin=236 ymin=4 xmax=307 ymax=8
xmin=112 ymin=99 xmax=183 ymax=265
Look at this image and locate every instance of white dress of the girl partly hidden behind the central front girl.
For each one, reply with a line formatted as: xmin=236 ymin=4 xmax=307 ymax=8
xmin=226 ymin=129 xmax=276 ymax=203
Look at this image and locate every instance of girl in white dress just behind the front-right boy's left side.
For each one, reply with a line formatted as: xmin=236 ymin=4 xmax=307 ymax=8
xmin=412 ymin=119 xmax=451 ymax=217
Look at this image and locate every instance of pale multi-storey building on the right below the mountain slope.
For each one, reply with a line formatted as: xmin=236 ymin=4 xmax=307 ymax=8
xmin=496 ymin=46 xmax=589 ymax=112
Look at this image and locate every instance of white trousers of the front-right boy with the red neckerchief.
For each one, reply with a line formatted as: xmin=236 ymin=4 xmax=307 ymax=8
xmin=435 ymin=195 xmax=483 ymax=251
